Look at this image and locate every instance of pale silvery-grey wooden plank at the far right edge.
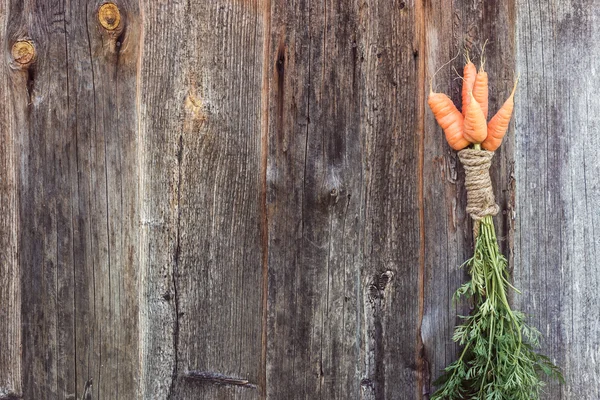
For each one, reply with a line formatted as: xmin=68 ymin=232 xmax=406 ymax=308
xmin=514 ymin=0 xmax=600 ymax=399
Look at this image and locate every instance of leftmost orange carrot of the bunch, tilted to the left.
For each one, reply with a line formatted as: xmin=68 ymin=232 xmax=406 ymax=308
xmin=427 ymin=88 xmax=469 ymax=150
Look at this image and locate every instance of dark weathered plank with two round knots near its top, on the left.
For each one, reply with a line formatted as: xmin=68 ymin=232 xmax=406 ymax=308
xmin=7 ymin=1 xmax=139 ymax=399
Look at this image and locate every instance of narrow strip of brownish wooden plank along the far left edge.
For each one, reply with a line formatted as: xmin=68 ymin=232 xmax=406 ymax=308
xmin=0 ymin=1 xmax=21 ymax=398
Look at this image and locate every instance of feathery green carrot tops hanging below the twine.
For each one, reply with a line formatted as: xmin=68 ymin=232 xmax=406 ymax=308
xmin=431 ymin=216 xmax=564 ymax=400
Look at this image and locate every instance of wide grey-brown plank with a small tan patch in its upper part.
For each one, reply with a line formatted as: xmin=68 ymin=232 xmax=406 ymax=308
xmin=139 ymin=1 xmax=264 ymax=399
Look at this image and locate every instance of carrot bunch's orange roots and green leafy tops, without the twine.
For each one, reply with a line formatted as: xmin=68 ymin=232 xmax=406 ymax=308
xmin=428 ymin=51 xmax=563 ymax=400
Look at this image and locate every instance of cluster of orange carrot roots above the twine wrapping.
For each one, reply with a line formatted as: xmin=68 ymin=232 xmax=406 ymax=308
xmin=427 ymin=54 xmax=517 ymax=151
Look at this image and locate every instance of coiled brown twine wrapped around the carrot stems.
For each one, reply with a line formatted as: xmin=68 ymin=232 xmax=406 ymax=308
xmin=458 ymin=149 xmax=500 ymax=221
